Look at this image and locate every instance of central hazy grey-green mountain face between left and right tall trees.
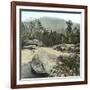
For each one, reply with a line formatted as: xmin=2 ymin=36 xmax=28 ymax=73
xmin=39 ymin=17 xmax=66 ymax=33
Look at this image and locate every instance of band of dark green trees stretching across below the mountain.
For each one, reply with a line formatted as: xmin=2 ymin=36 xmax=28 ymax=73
xmin=21 ymin=19 xmax=80 ymax=48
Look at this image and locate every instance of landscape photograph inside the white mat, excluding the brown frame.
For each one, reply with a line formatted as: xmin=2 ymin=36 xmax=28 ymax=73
xmin=20 ymin=9 xmax=81 ymax=79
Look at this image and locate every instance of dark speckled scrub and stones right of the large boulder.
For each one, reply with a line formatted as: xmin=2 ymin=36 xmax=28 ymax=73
xmin=51 ymin=54 xmax=80 ymax=77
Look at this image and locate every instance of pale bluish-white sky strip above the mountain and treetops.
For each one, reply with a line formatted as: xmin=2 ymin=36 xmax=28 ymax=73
xmin=21 ymin=11 xmax=81 ymax=23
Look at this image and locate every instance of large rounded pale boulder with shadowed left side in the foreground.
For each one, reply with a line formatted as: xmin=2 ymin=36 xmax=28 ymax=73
xmin=31 ymin=49 xmax=57 ymax=75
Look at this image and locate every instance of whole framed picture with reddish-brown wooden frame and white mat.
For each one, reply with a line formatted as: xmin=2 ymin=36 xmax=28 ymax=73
xmin=11 ymin=2 xmax=87 ymax=88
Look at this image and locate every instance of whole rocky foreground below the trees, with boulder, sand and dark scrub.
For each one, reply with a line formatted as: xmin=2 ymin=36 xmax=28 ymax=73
xmin=21 ymin=45 xmax=80 ymax=78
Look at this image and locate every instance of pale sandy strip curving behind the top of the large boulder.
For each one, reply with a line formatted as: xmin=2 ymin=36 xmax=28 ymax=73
xmin=21 ymin=47 xmax=70 ymax=64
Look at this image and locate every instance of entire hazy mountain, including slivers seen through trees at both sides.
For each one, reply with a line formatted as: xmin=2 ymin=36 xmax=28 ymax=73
xmin=24 ymin=17 xmax=80 ymax=33
